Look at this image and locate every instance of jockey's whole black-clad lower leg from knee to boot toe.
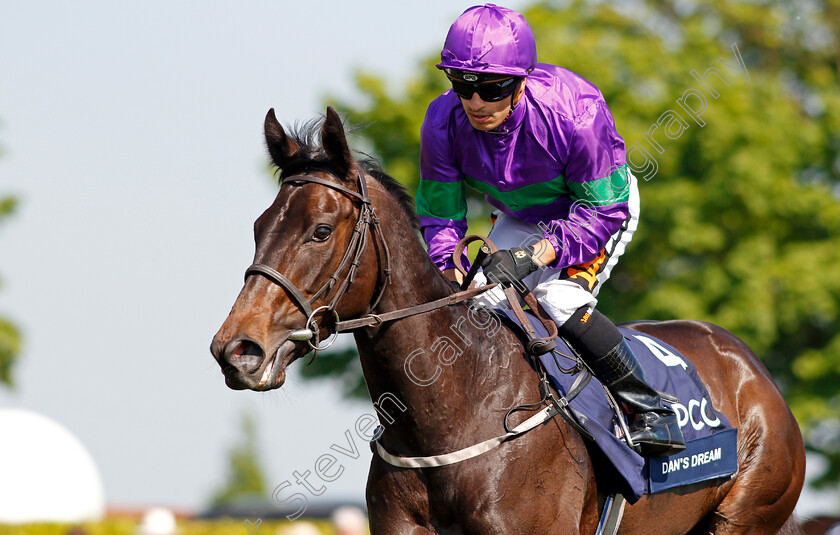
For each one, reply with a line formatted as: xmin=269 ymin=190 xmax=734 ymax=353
xmin=560 ymin=307 xmax=685 ymax=457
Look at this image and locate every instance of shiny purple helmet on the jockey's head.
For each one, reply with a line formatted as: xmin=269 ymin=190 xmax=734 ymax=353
xmin=436 ymin=4 xmax=537 ymax=76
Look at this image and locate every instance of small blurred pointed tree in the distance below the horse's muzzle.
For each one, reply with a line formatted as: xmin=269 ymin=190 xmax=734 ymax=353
xmin=212 ymin=414 xmax=268 ymax=505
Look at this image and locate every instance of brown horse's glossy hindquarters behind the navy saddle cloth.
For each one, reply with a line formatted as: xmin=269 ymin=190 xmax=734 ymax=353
xmin=640 ymin=322 xmax=805 ymax=535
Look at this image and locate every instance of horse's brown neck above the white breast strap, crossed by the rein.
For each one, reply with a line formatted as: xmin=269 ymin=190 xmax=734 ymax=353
xmin=356 ymin=224 xmax=535 ymax=450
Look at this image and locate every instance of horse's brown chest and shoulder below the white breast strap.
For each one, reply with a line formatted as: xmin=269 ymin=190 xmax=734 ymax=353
xmin=367 ymin=421 xmax=598 ymax=535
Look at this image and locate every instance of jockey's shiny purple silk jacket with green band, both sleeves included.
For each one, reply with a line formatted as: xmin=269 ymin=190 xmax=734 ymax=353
xmin=417 ymin=64 xmax=630 ymax=269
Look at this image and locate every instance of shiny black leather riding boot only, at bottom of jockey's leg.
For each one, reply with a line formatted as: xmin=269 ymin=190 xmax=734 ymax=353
xmin=586 ymin=338 xmax=685 ymax=457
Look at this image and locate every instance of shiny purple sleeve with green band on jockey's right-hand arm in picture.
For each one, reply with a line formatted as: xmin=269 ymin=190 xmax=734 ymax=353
xmin=543 ymin=100 xmax=629 ymax=268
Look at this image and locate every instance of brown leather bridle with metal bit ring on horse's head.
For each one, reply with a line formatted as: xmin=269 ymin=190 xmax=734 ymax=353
xmin=240 ymin=171 xmax=391 ymax=354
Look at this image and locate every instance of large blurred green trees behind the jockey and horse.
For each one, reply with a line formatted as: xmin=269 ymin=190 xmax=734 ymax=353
xmin=308 ymin=0 xmax=840 ymax=482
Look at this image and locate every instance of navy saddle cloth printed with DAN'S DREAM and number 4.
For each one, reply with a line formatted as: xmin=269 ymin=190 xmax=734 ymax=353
xmin=495 ymin=308 xmax=738 ymax=503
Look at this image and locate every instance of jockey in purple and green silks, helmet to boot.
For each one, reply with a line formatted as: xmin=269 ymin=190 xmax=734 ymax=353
xmin=416 ymin=4 xmax=685 ymax=456
